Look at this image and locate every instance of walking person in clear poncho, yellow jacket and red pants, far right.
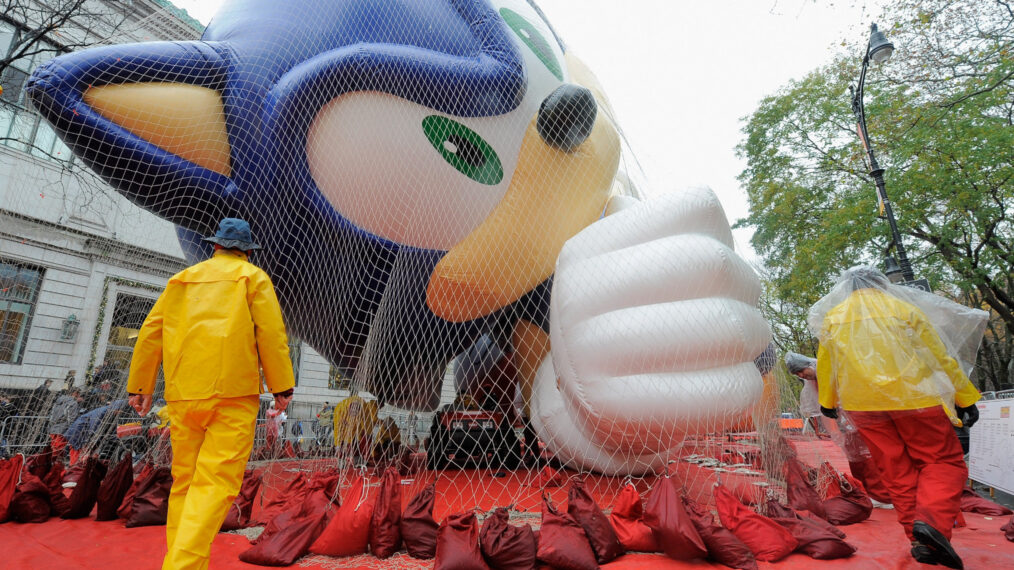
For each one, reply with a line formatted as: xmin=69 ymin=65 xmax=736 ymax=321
xmin=808 ymin=267 xmax=988 ymax=568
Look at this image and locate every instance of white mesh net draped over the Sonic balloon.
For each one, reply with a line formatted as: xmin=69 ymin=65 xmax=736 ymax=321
xmin=3 ymin=0 xmax=851 ymax=551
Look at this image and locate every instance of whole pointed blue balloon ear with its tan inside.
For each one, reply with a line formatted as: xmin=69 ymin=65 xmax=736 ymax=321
xmin=25 ymin=42 xmax=240 ymax=232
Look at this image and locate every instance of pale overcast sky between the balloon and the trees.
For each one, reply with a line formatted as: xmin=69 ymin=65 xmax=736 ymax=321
xmin=174 ymin=0 xmax=888 ymax=259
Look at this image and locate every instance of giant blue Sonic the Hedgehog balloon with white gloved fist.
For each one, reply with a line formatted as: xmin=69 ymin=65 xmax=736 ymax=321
xmin=27 ymin=0 xmax=769 ymax=472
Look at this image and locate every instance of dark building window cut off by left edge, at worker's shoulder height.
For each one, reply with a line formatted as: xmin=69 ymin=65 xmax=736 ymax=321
xmin=0 ymin=260 xmax=43 ymax=364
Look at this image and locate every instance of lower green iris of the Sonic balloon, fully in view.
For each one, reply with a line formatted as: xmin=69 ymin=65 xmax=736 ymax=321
xmin=423 ymin=115 xmax=504 ymax=186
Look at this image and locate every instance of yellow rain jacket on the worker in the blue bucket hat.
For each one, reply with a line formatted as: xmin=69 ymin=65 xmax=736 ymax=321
xmin=127 ymin=250 xmax=295 ymax=402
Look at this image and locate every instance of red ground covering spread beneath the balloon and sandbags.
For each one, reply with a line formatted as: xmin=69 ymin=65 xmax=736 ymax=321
xmin=0 ymin=436 xmax=1014 ymax=570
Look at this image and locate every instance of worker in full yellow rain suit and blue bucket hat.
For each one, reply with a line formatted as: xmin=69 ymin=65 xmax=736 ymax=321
xmin=127 ymin=218 xmax=295 ymax=569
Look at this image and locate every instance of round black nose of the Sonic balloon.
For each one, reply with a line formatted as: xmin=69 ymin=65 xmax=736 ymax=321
xmin=535 ymin=83 xmax=598 ymax=151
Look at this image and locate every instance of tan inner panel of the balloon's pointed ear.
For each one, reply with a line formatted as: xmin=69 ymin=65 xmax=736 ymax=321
xmin=84 ymin=83 xmax=232 ymax=176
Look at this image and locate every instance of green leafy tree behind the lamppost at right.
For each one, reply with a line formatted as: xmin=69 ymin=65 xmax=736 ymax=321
xmin=737 ymin=0 xmax=1014 ymax=388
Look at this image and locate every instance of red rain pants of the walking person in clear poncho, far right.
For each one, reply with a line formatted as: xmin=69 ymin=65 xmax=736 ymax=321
xmin=849 ymin=407 xmax=968 ymax=540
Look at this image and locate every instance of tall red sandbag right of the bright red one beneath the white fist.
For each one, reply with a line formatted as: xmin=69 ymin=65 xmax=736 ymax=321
xmin=644 ymin=477 xmax=708 ymax=560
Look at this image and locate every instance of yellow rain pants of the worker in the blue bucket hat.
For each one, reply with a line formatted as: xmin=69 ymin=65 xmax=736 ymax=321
xmin=162 ymin=396 xmax=260 ymax=570
